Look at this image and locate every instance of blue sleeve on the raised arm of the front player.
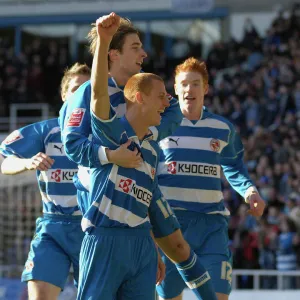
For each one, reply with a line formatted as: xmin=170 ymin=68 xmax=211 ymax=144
xmin=91 ymin=108 xmax=126 ymax=149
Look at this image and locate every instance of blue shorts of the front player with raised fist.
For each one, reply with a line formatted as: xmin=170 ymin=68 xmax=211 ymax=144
xmin=77 ymin=227 xmax=157 ymax=300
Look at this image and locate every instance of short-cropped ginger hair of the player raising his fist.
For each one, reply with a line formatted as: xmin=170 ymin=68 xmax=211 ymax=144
xmin=124 ymin=73 xmax=164 ymax=105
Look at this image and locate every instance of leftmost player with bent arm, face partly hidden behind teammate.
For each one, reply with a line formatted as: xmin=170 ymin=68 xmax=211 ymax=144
xmin=0 ymin=64 xmax=90 ymax=300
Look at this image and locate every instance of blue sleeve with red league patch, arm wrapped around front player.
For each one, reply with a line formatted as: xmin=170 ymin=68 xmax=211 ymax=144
xmin=60 ymin=81 xmax=108 ymax=168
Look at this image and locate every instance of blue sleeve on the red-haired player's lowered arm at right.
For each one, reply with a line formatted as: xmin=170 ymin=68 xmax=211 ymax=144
xmin=221 ymin=125 xmax=254 ymax=197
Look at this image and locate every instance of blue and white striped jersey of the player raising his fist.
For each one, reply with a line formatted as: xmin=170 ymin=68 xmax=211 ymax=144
xmin=82 ymin=113 xmax=160 ymax=230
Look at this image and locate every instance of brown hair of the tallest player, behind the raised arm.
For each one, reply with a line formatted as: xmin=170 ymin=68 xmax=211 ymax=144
xmin=87 ymin=18 xmax=139 ymax=65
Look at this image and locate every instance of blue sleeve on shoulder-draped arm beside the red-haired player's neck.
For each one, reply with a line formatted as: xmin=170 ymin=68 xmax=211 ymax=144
xmin=150 ymin=97 xmax=182 ymax=142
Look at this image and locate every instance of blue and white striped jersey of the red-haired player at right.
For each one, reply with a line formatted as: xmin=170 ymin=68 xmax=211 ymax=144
xmin=157 ymin=108 xmax=253 ymax=215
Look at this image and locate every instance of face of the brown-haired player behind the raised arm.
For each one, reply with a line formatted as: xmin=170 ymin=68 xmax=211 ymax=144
xmin=119 ymin=33 xmax=147 ymax=76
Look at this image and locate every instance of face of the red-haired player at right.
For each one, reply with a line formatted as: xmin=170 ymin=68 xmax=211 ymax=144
xmin=174 ymin=72 xmax=208 ymax=112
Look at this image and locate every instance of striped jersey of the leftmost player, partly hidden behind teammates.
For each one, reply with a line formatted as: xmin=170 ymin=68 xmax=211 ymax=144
xmin=0 ymin=118 xmax=81 ymax=215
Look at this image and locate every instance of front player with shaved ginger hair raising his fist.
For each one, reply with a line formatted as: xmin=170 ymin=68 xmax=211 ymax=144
xmin=78 ymin=17 xmax=169 ymax=300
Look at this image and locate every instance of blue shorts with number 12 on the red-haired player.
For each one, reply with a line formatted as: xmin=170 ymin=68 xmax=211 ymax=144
xmin=156 ymin=211 xmax=232 ymax=299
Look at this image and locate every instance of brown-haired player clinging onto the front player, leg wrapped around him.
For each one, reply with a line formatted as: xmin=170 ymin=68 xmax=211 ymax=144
xmin=61 ymin=12 xmax=216 ymax=300
